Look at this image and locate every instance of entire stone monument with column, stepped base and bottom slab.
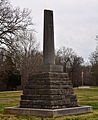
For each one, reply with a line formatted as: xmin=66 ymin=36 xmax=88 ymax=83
xmin=5 ymin=10 xmax=92 ymax=117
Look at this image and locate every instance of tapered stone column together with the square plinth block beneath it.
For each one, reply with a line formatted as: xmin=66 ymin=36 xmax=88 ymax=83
xmin=38 ymin=10 xmax=63 ymax=72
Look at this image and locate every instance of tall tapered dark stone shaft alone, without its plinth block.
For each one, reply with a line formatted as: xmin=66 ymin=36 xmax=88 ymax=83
xmin=43 ymin=10 xmax=55 ymax=65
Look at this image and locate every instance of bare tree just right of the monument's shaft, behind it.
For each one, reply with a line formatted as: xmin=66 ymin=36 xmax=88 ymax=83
xmin=56 ymin=47 xmax=83 ymax=86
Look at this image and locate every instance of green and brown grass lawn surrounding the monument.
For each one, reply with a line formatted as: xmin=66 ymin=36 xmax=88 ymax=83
xmin=0 ymin=89 xmax=98 ymax=120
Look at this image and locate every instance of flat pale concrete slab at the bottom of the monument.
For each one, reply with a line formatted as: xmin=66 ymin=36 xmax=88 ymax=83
xmin=5 ymin=106 xmax=92 ymax=118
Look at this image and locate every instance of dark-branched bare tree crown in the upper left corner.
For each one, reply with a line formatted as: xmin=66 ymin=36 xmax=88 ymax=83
xmin=0 ymin=0 xmax=33 ymax=51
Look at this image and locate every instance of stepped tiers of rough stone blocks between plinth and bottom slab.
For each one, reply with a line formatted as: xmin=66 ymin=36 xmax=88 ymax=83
xmin=20 ymin=72 xmax=78 ymax=109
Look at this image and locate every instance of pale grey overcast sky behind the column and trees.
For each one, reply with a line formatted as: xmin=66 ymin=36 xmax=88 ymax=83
xmin=10 ymin=0 xmax=98 ymax=61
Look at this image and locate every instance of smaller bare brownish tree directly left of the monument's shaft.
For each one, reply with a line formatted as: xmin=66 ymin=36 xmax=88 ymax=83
xmin=16 ymin=31 xmax=42 ymax=88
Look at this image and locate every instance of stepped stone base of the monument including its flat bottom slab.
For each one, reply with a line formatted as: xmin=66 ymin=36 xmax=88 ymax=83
xmin=5 ymin=72 xmax=92 ymax=117
